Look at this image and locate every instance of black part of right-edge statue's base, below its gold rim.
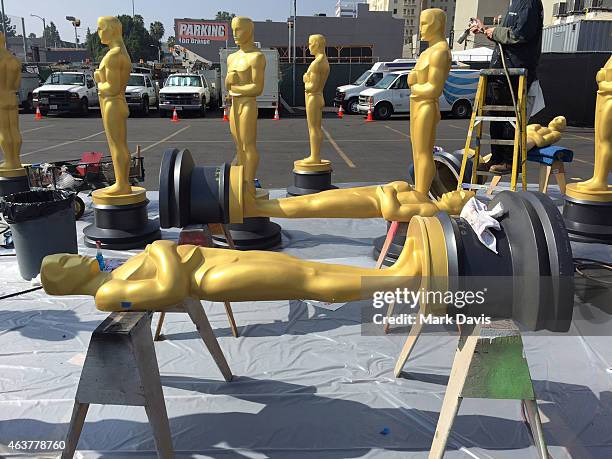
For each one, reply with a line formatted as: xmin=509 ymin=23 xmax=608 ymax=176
xmin=563 ymin=196 xmax=612 ymax=244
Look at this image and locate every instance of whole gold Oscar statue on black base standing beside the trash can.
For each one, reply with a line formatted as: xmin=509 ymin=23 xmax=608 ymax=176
xmin=83 ymin=16 xmax=160 ymax=250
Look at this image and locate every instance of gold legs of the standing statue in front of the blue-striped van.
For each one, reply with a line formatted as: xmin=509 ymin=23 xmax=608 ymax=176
xmin=410 ymin=103 xmax=440 ymax=196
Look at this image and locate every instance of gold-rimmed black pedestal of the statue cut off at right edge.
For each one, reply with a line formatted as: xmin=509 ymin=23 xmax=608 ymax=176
xmin=563 ymin=183 xmax=612 ymax=244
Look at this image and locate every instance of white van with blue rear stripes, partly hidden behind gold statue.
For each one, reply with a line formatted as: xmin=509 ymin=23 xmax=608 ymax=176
xmin=357 ymin=69 xmax=480 ymax=120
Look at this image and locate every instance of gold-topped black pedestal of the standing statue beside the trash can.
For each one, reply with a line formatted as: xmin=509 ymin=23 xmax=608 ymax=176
xmin=83 ymin=187 xmax=161 ymax=250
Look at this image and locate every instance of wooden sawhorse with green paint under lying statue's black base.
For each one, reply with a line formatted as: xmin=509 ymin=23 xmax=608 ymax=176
xmin=429 ymin=320 xmax=549 ymax=459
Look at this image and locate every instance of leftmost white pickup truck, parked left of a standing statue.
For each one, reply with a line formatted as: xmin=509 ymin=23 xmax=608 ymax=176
xmin=33 ymin=71 xmax=99 ymax=116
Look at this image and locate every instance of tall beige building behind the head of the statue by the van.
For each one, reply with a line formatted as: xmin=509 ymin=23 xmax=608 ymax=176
xmin=368 ymin=0 xmax=454 ymax=57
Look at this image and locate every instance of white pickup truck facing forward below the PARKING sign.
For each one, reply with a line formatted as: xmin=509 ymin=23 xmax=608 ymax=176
xmin=159 ymin=73 xmax=210 ymax=117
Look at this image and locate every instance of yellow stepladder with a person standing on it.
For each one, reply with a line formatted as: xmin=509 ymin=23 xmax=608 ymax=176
xmin=457 ymin=68 xmax=528 ymax=195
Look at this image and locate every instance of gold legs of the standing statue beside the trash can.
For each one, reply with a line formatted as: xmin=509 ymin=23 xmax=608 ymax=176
xmin=102 ymin=99 xmax=132 ymax=195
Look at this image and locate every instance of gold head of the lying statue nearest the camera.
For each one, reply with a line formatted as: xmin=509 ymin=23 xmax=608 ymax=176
xmin=40 ymin=253 xmax=101 ymax=295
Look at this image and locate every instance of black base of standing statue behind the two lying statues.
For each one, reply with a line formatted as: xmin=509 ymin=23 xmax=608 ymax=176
xmin=213 ymin=217 xmax=281 ymax=250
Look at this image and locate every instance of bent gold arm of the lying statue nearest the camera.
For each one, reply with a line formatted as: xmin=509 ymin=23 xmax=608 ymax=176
xmin=96 ymin=241 xmax=190 ymax=311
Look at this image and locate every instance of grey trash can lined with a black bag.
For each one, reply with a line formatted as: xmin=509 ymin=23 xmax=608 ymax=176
xmin=0 ymin=190 xmax=78 ymax=280
